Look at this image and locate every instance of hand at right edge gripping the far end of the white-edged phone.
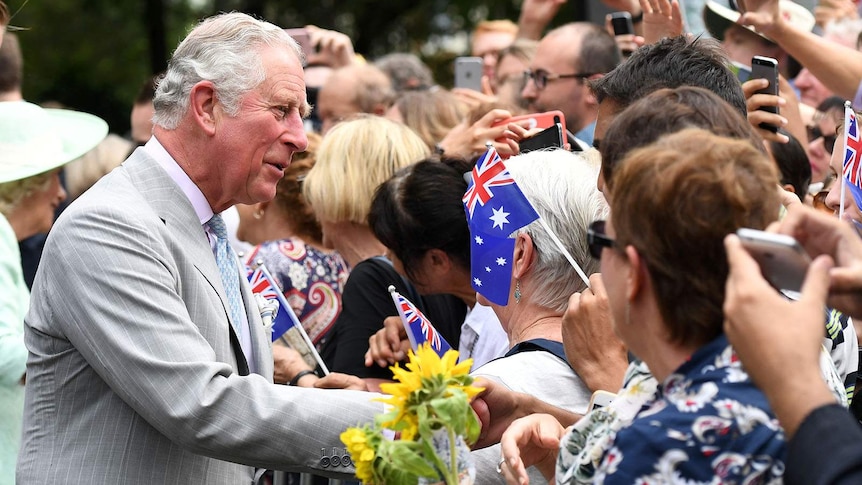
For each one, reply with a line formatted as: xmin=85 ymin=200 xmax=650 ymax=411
xmin=777 ymin=205 xmax=862 ymax=319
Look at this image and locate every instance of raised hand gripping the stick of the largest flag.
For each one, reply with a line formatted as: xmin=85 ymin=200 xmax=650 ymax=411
xmin=562 ymin=273 xmax=628 ymax=392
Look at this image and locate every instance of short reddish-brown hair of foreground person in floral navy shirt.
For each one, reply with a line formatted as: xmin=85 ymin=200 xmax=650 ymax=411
xmin=610 ymin=129 xmax=780 ymax=345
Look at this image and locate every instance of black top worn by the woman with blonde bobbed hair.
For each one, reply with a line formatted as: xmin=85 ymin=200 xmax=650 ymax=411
xmin=320 ymin=258 xmax=467 ymax=379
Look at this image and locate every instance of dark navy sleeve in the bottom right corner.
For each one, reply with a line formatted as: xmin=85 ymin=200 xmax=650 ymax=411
xmin=784 ymin=404 xmax=862 ymax=485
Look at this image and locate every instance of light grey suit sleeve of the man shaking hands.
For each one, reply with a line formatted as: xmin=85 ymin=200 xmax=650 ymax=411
xmin=35 ymin=202 xmax=382 ymax=474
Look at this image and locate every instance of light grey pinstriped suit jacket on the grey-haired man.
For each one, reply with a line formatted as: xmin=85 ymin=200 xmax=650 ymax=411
xmin=17 ymin=149 xmax=382 ymax=485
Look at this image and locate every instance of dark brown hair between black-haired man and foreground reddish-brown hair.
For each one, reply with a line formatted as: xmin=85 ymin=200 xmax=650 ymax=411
xmin=599 ymin=86 xmax=766 ymax=189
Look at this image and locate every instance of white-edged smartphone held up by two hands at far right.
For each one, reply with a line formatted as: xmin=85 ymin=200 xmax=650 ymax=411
xmin=736 ymin=228 xmax=811 ymax=292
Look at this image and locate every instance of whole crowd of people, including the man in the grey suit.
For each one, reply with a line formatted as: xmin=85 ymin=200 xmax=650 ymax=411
xmin=0 ymin=0 xmax=862 ymax=485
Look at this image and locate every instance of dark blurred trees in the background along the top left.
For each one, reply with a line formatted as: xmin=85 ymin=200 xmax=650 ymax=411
xmin=6 ymin=0 xmax=599 ymax=134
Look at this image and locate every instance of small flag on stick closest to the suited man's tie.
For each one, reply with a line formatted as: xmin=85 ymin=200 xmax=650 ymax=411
xmin=246 ymin=261 xmax=329 ymax=375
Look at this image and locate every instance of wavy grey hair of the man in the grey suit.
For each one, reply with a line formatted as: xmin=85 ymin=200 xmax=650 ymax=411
xmin=153 ymin=12 xmax=303 ymax=130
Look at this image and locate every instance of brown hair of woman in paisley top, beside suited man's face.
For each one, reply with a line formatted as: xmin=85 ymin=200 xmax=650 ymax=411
xmin=272 ymin=133 xmax=323 ymax=245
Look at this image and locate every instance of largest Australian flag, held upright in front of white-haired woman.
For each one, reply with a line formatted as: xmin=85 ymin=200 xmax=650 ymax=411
xmin=462 ymin=148 xmax=539 ymax=305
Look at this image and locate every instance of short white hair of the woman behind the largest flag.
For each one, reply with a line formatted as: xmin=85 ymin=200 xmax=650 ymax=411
xmin=506 ymin=150 xmax=608 ymax=313
